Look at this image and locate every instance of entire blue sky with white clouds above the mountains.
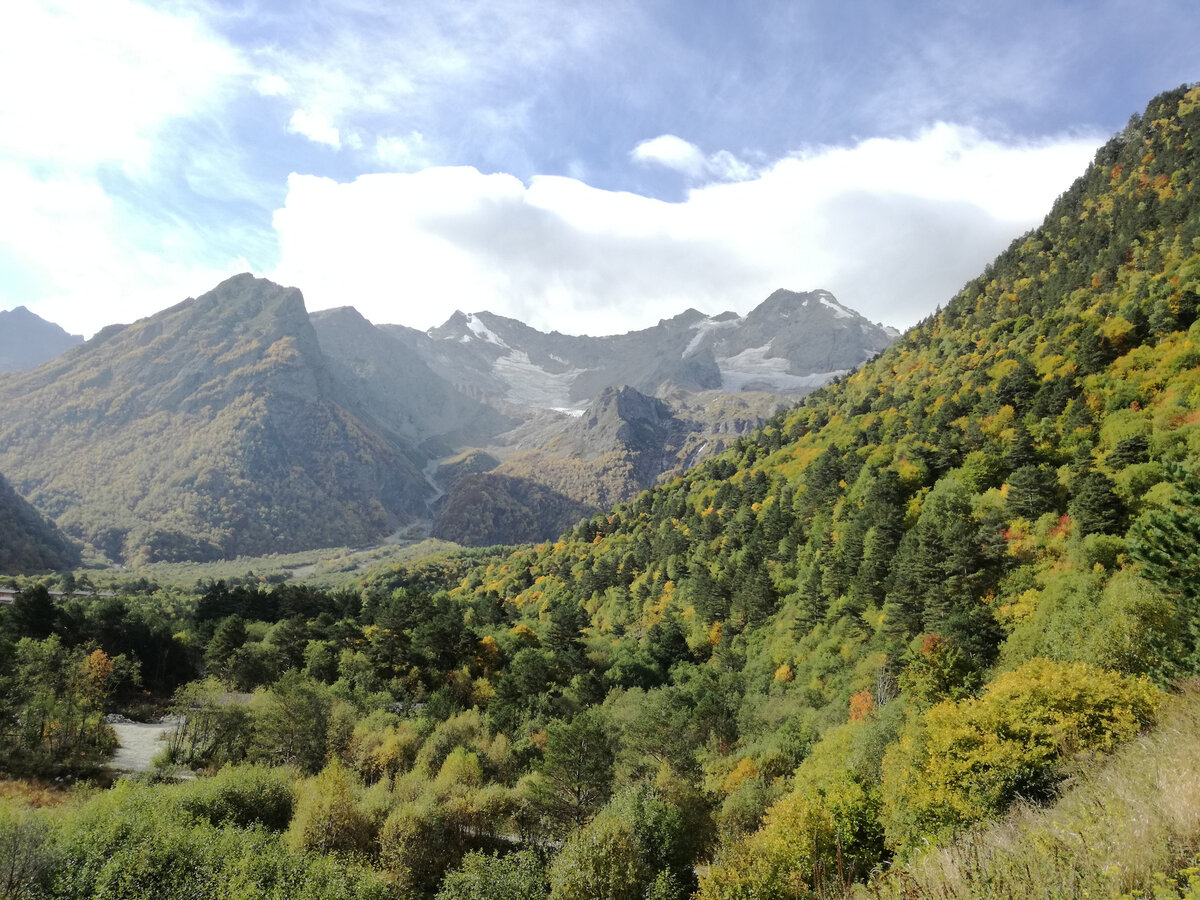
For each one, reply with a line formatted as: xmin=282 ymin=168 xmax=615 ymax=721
xmin=0 ymin=0 xmax=1200 ymax=335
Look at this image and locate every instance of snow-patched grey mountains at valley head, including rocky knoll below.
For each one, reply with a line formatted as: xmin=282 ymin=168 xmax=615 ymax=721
xmin=380 ymin=290 xmax=895 ymax=542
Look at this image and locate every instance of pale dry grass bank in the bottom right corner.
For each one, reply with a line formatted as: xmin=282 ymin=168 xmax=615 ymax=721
xmin=859 ymin=685 xmax=1200 ymax=900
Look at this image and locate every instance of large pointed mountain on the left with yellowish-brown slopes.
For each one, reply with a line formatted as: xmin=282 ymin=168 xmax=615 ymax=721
xmin=0 ymin=275 xmax=431 ymax=560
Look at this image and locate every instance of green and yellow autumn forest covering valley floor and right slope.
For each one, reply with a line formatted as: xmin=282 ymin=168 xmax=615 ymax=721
xmin=0 ymin=86 xmax=1200 ymax=900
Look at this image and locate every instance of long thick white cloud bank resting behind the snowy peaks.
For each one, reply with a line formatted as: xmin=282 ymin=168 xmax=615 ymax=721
xmin=271 ymin=125 xmax=1097 ymax=334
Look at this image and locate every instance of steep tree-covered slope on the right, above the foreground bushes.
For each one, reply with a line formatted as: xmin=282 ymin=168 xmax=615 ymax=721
xmin=453 ymin=81 xmax=1200 ymax=667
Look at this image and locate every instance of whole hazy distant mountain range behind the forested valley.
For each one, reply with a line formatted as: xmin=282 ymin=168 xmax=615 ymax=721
xmin=0 ymin=282 xmax=894 ymax=562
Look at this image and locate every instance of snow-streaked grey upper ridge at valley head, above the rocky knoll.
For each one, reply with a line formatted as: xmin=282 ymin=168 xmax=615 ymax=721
xmin=383 ymin=290 xmax=895 ymax=412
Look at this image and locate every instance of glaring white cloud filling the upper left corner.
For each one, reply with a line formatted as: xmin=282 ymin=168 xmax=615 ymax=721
xmin=0 ymin=0 xmax=247 ymax=334
